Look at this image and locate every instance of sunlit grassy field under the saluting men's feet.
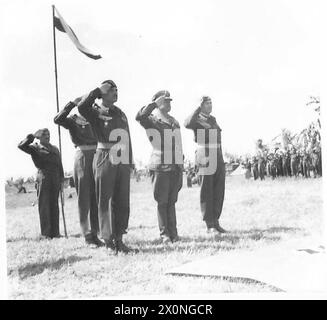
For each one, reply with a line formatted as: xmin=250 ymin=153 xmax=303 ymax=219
xmin=6 ymin=177 xmax=323 ymax=299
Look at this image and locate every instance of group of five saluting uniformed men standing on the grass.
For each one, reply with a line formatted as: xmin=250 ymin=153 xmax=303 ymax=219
xmin=18 ymin=80 xmax=226 ymax=253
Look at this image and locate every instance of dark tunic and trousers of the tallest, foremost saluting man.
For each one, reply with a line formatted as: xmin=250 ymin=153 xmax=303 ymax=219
xmin=78 ymin=88 xmax=133 ymax=240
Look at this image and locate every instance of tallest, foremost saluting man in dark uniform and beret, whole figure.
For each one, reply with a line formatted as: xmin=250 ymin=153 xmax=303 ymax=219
xmin=78 ymin=80 xmax=137 ymax=253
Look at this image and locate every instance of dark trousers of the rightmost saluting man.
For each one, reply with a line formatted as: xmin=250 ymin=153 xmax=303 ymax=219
xmin=200 ymin=152 xmax=225 ymax=228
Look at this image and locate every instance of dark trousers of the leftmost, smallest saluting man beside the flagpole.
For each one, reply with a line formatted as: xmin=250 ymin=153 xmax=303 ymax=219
xmin=37 ymin=170 xmax=61 ymax=238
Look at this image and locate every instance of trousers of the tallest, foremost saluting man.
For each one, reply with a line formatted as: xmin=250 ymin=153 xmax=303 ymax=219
xmin=93 ymin=149 xmax=130 ymax=240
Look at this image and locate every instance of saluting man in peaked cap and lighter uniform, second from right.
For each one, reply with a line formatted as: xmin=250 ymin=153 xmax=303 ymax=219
xmin=136 ymin=90 xmax=183 ymax=243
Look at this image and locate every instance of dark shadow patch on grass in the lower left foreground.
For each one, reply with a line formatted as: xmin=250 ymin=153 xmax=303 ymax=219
xmin=9 ymin=256 xmax=91 ymax=280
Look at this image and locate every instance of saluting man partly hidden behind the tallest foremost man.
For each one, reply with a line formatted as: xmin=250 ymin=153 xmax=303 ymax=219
xmin=54 ymin=98 xmax=104 ymax=247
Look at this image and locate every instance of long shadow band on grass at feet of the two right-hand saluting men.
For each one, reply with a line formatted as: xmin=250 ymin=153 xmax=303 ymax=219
xmin=137 ymin=227 xmax=303 ymax=253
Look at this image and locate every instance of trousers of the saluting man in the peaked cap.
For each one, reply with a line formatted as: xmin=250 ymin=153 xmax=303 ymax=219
xmin=152 ymin=168 xmax=183 ymax=238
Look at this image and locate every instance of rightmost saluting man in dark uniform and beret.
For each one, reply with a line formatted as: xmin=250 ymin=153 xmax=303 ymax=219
xmin=184 ymin=96 xmax=226 ymax=234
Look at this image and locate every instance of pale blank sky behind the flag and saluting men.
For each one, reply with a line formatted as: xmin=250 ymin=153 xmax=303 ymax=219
xmin=0 ymin=0 xmax=326 ymax=177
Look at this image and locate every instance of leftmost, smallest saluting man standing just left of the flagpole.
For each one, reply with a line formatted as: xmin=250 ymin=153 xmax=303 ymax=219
xmin=18 ymin=128 xmax=64 ymax=238
